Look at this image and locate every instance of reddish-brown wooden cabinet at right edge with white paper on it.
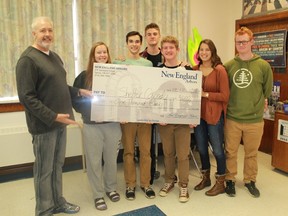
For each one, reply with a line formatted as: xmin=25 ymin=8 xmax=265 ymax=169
xmin=272 ymin=112 xmax=288 ymax=172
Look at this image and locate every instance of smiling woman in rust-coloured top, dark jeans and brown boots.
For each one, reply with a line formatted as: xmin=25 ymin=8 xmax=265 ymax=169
xmin=193 ymin=39 xmax=230 ymax=196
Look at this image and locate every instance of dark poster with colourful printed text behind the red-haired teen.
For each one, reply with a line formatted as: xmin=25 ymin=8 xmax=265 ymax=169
xmin=252 ymin=29 xmax=287 ymax=68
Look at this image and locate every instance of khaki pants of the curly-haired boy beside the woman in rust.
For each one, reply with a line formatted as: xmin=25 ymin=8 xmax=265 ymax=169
xmin=159 ymin=124 xmax=191 ymax=186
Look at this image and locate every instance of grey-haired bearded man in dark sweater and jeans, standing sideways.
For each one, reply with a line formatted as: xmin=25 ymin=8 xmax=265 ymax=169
xmin=16 ymin=17 xmax=92 ymax=216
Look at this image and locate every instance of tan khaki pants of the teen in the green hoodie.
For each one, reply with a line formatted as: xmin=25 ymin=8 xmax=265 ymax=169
xmin=224 ymin=119 xmax=264 ymax=183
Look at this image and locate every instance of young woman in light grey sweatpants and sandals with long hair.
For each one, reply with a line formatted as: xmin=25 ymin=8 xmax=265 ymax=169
xmin=73 ymin=42 xmax=121 ymax=210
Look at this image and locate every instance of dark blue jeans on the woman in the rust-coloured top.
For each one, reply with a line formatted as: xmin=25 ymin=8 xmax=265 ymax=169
xmin=194 ymin=113 xmax=226 ymax=175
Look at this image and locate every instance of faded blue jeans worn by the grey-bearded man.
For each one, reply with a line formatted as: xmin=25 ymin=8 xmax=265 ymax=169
xmin=32 ymin=127 xmax=66 ymax=216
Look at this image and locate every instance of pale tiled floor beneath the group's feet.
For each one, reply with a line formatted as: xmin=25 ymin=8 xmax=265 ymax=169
xmin=0 ymin=147 xmax=288 ymax=216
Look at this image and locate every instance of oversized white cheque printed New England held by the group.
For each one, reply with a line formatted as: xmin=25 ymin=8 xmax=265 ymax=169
xmin=91 ymin=63 xmax=202 ymax=124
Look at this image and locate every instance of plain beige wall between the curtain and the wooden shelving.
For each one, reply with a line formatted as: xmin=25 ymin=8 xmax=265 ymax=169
xmin=188 ymin=0 xmax=242 ymax=63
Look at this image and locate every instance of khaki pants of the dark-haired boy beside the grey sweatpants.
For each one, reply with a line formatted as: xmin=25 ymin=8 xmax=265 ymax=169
xmin=121 ymin=123 xmax=151 ymax=188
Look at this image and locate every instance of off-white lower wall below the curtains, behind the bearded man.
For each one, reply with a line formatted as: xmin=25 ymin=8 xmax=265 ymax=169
xmin=0 ymin=112 xmax=82 ymax=167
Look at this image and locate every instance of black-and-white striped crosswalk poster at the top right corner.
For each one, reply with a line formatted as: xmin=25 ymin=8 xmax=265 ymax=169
xmin=242 ymin=0 xmax=288 ymax=18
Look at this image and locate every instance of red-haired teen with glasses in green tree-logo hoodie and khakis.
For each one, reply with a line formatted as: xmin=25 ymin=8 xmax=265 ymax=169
xmin=224 ymin=27 xmax=273 ymax=197
